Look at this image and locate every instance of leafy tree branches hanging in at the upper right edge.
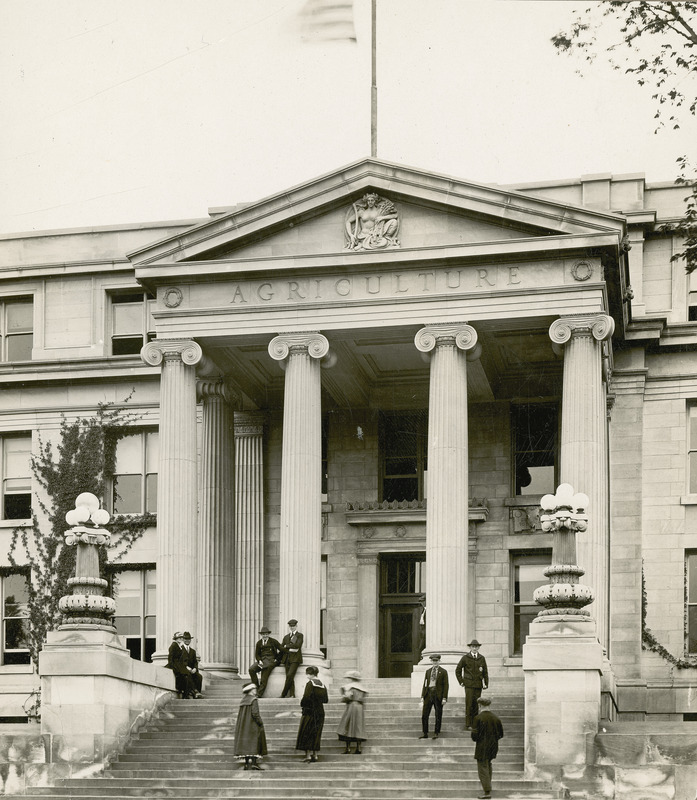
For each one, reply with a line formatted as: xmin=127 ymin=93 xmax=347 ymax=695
xmin=552 ymin=0 xmax=697 ymax=272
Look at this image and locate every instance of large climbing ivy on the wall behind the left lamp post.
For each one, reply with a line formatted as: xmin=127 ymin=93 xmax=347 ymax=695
xmin=8 ymin=403 xmax=156 ymax=666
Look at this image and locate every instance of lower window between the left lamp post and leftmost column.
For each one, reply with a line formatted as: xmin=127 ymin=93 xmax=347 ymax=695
xmin=111 ymin=566 xmax=155 ymax=661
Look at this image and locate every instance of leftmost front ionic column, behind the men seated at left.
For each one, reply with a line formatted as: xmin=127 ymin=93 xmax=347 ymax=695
xmin=140 ymin=339 xmax=203 ymax=661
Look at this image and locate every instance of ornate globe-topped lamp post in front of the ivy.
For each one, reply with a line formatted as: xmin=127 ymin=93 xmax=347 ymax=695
xmin=58 ymin=492 xmax=116 ymax=633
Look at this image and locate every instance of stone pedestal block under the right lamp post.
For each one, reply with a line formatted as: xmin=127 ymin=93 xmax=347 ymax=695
xmin=523 ymin=615 xmax=603 ymax=781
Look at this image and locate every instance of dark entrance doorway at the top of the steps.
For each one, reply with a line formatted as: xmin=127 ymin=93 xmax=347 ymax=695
xmin=378 ymin=553 xmax=426 ymax=678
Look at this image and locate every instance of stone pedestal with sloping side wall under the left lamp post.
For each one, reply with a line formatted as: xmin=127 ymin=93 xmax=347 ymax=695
xmin=39 ymin=626 xmax=174 ymax=775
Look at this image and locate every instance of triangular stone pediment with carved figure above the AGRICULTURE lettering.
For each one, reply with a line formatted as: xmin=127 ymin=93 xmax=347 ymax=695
xmin=129 ymin=159 xmax=622 ymax=272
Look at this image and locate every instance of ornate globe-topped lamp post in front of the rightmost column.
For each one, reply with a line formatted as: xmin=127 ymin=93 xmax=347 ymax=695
xmin=533 ymin=483 xmax=594 ymax=622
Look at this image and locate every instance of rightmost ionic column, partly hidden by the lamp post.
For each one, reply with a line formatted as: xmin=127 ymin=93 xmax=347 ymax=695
xmin=549 ymin=314 xmax=615 ymax=647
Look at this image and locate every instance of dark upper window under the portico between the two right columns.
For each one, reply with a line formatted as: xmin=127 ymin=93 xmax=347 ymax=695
xmin=511 ymin=404 xmax=558 ymax=495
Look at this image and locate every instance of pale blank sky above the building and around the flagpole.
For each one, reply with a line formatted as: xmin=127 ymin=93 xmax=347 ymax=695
xmin=0 ymin=0 xmax=697 ymax=234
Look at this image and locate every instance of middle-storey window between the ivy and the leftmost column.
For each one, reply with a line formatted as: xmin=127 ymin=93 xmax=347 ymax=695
xmin=112 ymin=431 xmax=159 ymax=514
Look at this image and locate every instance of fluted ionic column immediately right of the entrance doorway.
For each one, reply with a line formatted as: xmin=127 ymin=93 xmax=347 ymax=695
xmin=414 ymin=324 xmax=479 ymax=665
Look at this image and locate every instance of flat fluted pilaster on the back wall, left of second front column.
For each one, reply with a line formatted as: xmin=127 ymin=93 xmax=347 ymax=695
xmin=235 ymin=413 xmax=266 ymax=675
